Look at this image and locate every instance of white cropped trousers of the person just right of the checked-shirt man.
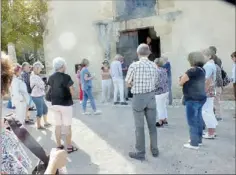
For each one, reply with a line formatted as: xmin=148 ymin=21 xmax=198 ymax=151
xmin=155 ymin=92 xmax=169 ymax=120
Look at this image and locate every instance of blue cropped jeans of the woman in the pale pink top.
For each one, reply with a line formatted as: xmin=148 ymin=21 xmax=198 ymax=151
xmin=32 ymin=96 xmax=48 ymax=117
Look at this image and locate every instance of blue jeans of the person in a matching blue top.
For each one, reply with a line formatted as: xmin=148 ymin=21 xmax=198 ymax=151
xmin=82 ymin=88 xmax=97 ymax=112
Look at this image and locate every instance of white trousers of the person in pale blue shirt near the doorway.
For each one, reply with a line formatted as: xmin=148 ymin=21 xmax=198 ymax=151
xmin=113 ymin=78 xmax=124 ymax=102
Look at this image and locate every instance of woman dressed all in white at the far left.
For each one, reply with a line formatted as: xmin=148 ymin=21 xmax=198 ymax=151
xmin=10 ymin=64 xmax=30 ymax=124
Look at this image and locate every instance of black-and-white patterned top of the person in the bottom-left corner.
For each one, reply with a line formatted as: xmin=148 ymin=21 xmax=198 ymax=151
xmin=0 ymin=128 xmax=31 ymax=174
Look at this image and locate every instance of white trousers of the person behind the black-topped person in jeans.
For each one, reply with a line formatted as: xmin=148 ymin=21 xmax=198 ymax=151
xmin=202 ymin=97 xmax=218 ymax=128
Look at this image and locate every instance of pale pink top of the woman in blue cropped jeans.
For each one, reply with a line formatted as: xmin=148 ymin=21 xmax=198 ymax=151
xmin=30 ymin=73 xmax=45 ymax=97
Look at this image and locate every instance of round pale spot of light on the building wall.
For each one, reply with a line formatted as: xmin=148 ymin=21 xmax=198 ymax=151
xmin=59 ymin=32 xmax=77 ymax=50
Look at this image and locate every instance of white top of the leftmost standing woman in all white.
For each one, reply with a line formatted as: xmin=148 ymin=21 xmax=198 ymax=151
xmin=10 ymin=76 xmax=30 ymax=106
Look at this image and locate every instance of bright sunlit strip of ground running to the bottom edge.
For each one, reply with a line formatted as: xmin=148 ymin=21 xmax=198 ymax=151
xmin=72 ymin=118 xmax=136 ymax=174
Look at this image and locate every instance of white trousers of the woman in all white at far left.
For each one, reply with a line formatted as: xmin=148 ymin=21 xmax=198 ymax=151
xmin=15 ymin=102 xmax=27 ymax=125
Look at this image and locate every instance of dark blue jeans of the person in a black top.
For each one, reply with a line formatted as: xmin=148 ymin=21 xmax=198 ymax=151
xmin=185 ymin=101 xmax=205 ymax=146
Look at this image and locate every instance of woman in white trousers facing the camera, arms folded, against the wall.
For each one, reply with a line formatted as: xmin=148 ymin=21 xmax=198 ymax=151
xmin=101 ymin=61 xmax=111 ymax=103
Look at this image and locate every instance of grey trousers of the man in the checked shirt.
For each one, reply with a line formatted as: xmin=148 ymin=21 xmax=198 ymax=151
xmin=132 ymin=92 xmax=158 ymax=154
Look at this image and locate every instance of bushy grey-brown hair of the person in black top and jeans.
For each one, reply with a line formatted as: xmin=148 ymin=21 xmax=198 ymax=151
xmin=188 ymin=52 xmax=205 ymax=67
